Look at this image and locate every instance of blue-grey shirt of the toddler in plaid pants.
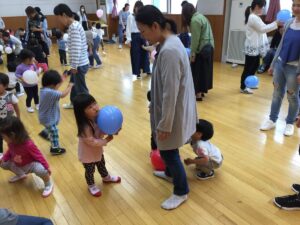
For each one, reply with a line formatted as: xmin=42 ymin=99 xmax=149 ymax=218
xmin=39 ymin=87 xmax=61 ymax=127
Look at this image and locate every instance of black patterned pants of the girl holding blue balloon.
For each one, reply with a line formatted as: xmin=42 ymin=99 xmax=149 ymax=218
xmin=83 ymin=155 xmax=108 ymax=185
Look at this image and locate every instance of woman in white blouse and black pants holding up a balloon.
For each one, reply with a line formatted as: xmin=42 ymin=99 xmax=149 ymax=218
xmin=240 ymin=0 xmax=277 ymax=94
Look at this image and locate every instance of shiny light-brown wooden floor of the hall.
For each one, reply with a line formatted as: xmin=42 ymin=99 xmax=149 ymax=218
xmin=0 ymin=45 xmax=300 ymax=225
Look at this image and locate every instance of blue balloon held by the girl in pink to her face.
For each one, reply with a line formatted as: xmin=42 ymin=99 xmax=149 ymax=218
xmin=97 ymin=105 xmax=123 ymax=135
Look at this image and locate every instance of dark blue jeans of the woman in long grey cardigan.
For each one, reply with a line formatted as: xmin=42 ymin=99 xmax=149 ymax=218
xmin=160 ymin=149 xmax=189 ymax=195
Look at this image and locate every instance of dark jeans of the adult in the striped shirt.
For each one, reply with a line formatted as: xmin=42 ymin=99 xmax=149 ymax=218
xmin=70 ymin=64 xmax=89 ymax=102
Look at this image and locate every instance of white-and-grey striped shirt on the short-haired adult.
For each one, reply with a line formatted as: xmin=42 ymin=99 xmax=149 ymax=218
xmin=68 ymin=21 xmax=89 ymax=69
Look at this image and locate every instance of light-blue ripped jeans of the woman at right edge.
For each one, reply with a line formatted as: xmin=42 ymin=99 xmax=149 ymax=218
xmin=270 ymin=60 xmax=299 ymax=124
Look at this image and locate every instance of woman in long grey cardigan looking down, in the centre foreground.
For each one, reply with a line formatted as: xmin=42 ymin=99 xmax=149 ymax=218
xmin=136 ymin=5 xmax=197 ymax=209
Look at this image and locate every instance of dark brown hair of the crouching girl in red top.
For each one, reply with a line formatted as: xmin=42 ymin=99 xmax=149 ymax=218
xmin=0 ymin=116 xmax=29 ymax=145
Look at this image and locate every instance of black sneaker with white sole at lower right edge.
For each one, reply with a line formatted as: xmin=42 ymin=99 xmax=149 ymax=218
xmin=273 ymin=194 xmax=300 ymax=210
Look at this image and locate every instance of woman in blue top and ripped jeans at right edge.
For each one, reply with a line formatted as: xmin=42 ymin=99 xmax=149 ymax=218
xmin=260 ymin=0 xmax=300 ymax=136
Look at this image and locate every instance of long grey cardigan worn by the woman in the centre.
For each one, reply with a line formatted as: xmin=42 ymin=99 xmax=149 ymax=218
xmin=150 ymin=35 xmax=197 ymax=150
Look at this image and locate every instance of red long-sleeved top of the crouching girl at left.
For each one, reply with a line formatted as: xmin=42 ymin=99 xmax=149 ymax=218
xmin=3 ymin=139 xmax=49 ymax=170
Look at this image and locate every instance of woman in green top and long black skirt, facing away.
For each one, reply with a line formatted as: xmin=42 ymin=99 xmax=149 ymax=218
xmin=182 ymin=3 xmax=214 ymax=101
